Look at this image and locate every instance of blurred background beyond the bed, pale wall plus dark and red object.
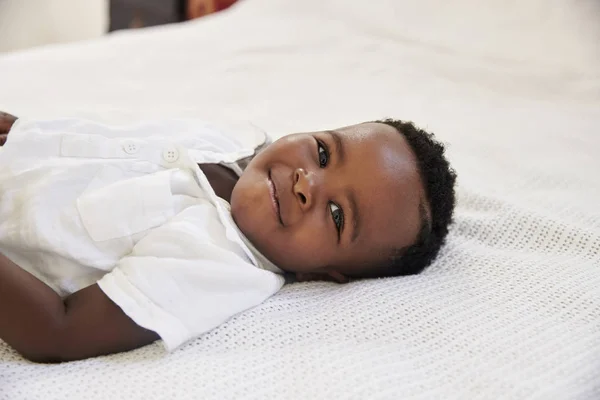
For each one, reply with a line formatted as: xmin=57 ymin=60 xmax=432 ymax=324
xmin=0 ymin=0 xmax=237 ymax=52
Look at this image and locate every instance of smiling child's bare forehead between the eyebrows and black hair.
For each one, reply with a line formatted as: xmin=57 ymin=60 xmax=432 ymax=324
xmin=338 ymin=123 xmax=424 ymax=266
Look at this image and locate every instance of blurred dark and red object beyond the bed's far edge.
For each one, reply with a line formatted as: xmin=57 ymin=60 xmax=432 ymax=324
xmin=109 ymin=0 xmax=237 ymax=32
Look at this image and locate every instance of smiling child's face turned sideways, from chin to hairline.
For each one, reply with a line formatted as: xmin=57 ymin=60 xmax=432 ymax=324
xmin=231 ymin=123 xmax=426 ymax=281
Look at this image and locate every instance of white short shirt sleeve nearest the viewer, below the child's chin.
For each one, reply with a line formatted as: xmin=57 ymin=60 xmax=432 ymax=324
xmin=98 ymin=206 xmax=284 ymax=351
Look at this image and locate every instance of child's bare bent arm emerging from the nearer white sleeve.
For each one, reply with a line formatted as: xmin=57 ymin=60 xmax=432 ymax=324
xmin=0 ymin=254 xmax=158 ymax=362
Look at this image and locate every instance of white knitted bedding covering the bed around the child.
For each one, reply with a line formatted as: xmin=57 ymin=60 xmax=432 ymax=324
xmin=0 ymin=0 xmax=600 ymax=400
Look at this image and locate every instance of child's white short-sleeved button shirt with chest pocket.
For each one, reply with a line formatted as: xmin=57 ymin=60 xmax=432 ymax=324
xmin=0 ymin=119 xmax=284 ymax=350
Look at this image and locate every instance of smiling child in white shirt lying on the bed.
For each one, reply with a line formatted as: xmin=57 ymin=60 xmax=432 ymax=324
xmin=0 ymin=110 xmax=455 ymax=362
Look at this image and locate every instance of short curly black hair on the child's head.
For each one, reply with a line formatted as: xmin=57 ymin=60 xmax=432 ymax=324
xmin=373 ymin=119 xmax=456 ymax=276
